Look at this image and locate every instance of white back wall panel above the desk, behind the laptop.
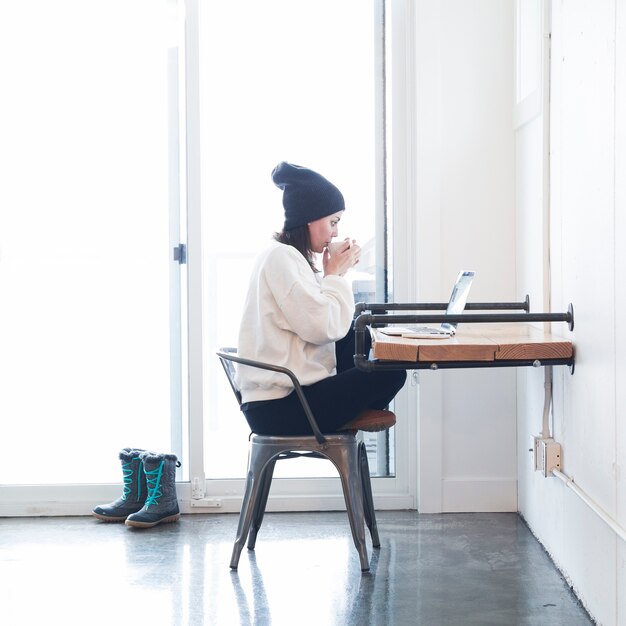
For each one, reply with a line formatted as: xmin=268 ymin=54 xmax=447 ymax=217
xmin=440 ymin=0 xmax=516 ymax=299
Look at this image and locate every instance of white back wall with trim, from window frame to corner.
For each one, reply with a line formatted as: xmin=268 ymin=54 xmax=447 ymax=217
xmin=414 ymin=0 xmax=525 ymax=512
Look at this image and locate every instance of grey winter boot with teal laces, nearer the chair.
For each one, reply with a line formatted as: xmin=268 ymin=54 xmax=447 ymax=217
xmin=126 ymin=452 xmax=180 ymax=528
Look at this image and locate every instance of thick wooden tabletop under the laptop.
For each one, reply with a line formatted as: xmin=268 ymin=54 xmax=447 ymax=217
xmin=372 ymin=323 xmax=573 ymax=362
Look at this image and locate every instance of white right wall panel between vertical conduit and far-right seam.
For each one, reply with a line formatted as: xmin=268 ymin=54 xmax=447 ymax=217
xmin=553 ymin=2 xmax=617 ymax=624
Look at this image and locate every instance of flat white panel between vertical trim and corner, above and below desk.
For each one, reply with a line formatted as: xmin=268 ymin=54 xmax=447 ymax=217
xmin=440 ymin=0 xmax=512 ymax=511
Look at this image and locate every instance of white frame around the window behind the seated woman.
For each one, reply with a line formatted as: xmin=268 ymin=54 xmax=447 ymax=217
xmin=185 ymin=0 xmax=417 ymax=513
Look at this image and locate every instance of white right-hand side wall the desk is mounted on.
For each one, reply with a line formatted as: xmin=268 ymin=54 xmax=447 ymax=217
xmin=517 ymin=0 xmax=626 ymax=626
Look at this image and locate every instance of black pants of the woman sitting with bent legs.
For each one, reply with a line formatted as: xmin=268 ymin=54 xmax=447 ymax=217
xmin=243 ymin=329 xmax=406 ymax=435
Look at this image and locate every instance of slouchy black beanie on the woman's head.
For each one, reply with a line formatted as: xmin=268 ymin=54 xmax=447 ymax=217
xmin=272 ymin=161 xmax=346 ymax=230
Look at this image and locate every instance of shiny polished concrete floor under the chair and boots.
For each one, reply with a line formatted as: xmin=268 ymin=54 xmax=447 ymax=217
xmin=0 ymin=511 xmax=593 ymax=626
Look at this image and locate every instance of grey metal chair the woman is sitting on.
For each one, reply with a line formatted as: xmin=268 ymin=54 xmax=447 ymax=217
xmin=217 ymin=348 xmax=380 ymax=571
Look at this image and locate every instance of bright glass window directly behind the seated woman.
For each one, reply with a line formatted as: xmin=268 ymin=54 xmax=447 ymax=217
xmin=200 ymin=0 xmax=394 ymax=478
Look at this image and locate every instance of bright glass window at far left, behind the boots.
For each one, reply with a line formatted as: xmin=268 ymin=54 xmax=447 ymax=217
xmin=0 ymin=0 xmax=180 ymax=484
